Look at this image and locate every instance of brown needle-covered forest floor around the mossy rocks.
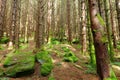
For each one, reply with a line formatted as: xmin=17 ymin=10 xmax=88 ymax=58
xmin=0 ymin=41 xmax=120 ymax=80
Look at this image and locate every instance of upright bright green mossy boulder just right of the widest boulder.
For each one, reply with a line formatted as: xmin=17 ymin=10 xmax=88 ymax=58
xmin=36 ymin=51 xmax=53 ymax=76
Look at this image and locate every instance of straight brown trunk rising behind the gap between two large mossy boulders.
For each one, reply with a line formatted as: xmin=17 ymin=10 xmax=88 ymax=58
xmin=36 ymin=0 xmax=45 ymax=49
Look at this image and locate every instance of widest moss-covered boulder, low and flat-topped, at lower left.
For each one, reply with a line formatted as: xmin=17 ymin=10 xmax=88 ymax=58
xmin=3 ymin=53 xmax=35 ymax=77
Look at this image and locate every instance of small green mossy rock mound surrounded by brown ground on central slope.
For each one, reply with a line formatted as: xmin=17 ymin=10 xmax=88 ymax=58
xmin=62 ymin=47 xmax=78 ymax=62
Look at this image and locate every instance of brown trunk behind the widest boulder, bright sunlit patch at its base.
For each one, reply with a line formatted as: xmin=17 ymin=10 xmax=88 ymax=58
xmin=9 ymin=0 xmax=21 ymax=49
